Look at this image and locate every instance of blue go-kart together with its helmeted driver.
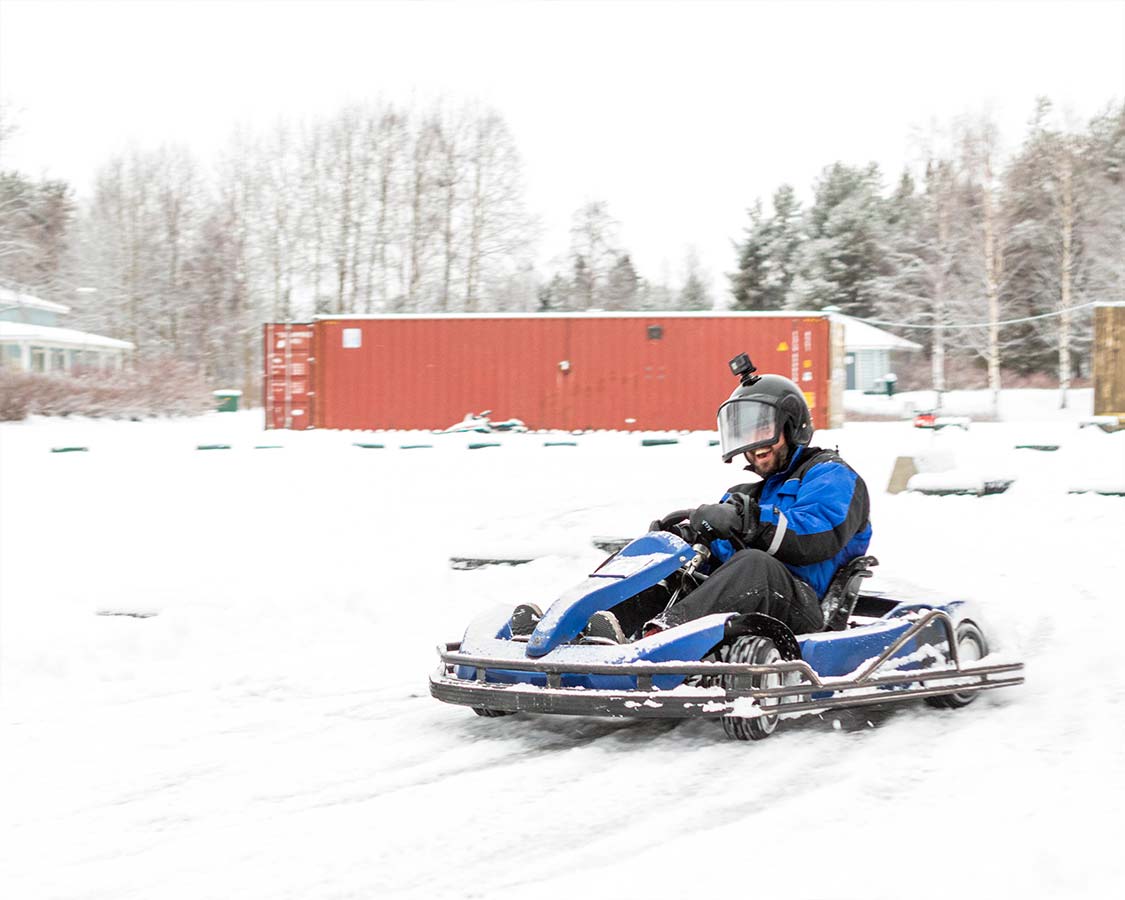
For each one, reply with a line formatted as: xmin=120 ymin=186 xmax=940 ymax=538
xmin=430 ymin=353 xmax=1023 ymax=740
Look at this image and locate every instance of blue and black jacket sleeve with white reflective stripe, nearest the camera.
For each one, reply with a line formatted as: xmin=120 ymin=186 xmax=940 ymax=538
xmin=753 ymin=462 xmax=871 ymax=566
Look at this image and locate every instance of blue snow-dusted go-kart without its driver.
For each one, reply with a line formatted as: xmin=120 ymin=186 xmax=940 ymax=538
xmin=430 ymin=531 xmax=1024 ymax=740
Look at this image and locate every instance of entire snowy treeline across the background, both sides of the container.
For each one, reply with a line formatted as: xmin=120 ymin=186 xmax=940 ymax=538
xmin=0 ymin=100 xmax=1125 ymax=400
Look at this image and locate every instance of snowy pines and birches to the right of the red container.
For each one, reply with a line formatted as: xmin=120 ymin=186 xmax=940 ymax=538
xmin=730 ymin=99 xmax=1125 ymax=402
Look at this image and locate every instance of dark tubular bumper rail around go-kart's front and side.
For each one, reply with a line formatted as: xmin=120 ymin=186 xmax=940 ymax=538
xmin=430 ymin=610 xmax=1024 ymax=718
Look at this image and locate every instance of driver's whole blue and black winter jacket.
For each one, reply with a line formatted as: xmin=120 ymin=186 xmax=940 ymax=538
xmin=711 ymin=447 xmax=871 ymax=597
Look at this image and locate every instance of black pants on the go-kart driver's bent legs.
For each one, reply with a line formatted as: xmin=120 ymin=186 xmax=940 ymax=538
xmin=659 ymin=550 xmax=825 ymax=635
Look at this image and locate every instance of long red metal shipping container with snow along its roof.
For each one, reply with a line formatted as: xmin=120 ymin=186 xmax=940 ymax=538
xmin=266 ymin=313 xmax=844 ymax=431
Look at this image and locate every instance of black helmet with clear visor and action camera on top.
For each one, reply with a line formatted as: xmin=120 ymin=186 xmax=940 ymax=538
xmin=719 ymin=353 xmax=812 ymax=462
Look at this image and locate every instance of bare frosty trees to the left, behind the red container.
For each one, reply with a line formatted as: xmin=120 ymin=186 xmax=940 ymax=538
xmin=0 ymin=98 xmax=711 ymax=389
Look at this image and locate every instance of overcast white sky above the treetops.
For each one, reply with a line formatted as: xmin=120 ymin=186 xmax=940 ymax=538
xmin=0 ymin=0 xmax=1125 ymax=290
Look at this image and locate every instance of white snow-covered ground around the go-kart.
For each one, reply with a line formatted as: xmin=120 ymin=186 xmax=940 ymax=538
xmin=0 ymin=394 xmax=1125 ymax=900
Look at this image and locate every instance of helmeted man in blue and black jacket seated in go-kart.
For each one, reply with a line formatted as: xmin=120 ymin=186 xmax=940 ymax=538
xmin=591 ymin=353 xmax=871 ymax=637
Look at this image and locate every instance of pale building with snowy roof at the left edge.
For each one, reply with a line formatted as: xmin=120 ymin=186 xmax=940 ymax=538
xmin=0 ymin=286 xmax=134 ymax=372
